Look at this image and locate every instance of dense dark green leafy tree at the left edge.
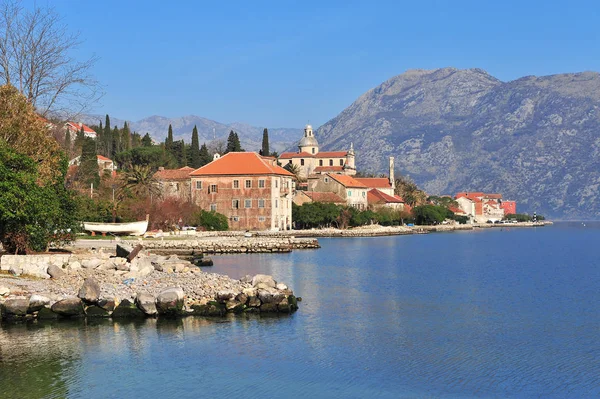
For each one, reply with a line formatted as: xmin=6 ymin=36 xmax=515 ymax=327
xmin=0 ymin=144 xmax=77 ymax=253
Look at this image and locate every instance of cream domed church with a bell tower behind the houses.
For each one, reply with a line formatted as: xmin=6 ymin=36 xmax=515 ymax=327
xmin=278 ymin=125 xmax=356 ymax=179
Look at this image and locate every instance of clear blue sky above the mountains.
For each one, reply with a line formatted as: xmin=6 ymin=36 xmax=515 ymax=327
xmin=37 ymin=0 xmax=600 ymax=128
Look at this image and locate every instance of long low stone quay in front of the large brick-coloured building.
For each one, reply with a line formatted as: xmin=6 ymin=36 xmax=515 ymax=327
xmin=141 ymin=236 xmax=321 ymax=254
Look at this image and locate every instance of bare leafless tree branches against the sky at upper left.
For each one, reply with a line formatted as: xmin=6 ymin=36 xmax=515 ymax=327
xmin=0 ymin=0 xmax=102 ymax=119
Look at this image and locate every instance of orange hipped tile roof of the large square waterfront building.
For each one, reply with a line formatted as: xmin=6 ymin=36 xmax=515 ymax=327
xmin=190 ymin=152 xmax=294 ymax=177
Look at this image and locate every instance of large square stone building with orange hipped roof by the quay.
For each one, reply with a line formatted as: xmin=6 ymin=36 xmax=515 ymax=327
xmin=189 ymin=152 xmax=295 ymax=230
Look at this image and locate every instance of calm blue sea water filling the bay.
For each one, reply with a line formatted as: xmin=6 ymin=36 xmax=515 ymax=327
xmin=0 ymin=222 xmax=600 ymax=398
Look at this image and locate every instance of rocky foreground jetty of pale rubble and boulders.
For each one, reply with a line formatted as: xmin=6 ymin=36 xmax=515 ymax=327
xmin=0 ymin=251 xmax=298 ymax=320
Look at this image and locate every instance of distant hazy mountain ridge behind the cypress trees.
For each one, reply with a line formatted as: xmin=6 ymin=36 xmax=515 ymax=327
xmin=81 ymin=115 xmax=303 ymax=152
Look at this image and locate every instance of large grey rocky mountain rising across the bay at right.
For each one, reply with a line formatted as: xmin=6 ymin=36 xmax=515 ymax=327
xmin=317 ymin=68 xmax=600 ymax=219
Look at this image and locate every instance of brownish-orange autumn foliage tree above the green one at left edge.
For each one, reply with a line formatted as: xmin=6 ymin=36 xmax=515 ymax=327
xmin=0 ymin=86 xmax=62 ymax=182
